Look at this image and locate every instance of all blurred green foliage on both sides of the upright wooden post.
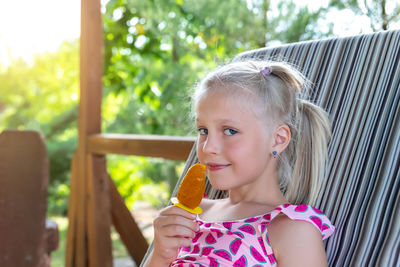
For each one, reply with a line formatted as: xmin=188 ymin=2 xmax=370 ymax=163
xmin=0 ymin=0 xmax=338 ymax=215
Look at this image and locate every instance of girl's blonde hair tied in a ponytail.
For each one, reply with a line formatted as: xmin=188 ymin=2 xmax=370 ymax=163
xmin=193 ymin=60 xmax=330 ymax=204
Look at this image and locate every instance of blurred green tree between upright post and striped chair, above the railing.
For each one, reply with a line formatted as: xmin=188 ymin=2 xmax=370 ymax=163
xmin=104 ymin=0 xmax=330 ymax=135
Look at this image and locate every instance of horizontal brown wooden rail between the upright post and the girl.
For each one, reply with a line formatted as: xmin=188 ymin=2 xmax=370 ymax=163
xmin=88 ymin=134 xmax=196 ymax=160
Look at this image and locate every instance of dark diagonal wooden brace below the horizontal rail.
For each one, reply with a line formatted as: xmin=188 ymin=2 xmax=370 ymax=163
xmin=108 ymin=177 xmax=148 ymax=266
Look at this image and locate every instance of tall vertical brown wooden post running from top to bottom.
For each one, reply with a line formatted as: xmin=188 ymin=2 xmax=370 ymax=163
xmin=78 ymin=0 xmax=112 ymax=267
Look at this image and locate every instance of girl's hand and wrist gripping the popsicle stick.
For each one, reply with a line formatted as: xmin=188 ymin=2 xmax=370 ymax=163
xmin=144 ymin=206 xmax=198 ymax=267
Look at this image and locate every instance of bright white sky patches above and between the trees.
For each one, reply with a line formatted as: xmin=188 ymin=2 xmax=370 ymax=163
xmin=0 ymin=0 xmax=400 ymax=66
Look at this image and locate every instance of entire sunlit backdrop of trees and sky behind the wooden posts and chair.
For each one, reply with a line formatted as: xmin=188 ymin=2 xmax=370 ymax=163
xmin=0 ymin=0 xmax=400 ymax=267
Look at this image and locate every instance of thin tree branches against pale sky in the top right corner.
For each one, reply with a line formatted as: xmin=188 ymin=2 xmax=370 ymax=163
xmin=329 ymin=0 xmax=400 ymax=32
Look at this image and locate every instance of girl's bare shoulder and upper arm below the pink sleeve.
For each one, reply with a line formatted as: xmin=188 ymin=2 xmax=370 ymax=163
xmin=268 ymin=214 xmax=328 ymax=267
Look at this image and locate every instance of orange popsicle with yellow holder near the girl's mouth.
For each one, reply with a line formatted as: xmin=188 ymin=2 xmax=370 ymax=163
xmin=171 ymin=163 xmax=206 ymax=214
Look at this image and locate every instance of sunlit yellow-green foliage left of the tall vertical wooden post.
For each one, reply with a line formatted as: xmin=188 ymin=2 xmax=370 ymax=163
xmin=0 ymin=41 xmax=79 ymax=214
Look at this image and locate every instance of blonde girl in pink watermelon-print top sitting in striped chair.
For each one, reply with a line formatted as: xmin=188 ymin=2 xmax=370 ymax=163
xmin=145 ymin=61 xmax=335 ymax=267
